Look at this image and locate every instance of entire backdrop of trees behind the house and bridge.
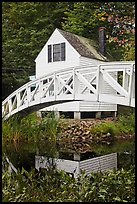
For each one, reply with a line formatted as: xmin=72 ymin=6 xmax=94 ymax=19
xmin=2 ymin=2 xmax=135 ymax=99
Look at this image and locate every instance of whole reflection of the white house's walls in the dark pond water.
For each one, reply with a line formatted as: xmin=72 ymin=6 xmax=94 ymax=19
xmin=35 ymin=153 xmax=117 ymax=177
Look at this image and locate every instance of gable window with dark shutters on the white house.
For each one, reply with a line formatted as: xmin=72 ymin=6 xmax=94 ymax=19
xmin=48 ymin=43 xmax=65 ymax=62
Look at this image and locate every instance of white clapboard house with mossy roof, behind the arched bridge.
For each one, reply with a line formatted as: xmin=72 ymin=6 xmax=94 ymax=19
xmin=35 ymin=28 xmax=117 ymax=118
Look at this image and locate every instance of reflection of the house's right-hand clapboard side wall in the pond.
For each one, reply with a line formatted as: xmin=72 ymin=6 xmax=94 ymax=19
xmin=80 ymin=153 xmax=117 ymax=175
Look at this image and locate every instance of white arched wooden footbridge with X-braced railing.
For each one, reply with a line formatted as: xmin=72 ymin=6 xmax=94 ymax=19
xmin=2 ymin=62 xmax=135 ymax=119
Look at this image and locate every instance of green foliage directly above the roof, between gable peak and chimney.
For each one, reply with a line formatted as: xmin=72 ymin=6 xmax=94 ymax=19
xmin=62 ymin=2 xmax=100 ymax=40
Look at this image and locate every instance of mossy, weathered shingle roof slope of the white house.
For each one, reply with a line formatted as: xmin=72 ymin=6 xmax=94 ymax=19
xmin=58 ymin=29 xmax=109 ymax=61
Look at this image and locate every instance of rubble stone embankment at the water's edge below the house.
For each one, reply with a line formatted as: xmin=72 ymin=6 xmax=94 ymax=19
xmin=57 ymin=117 xmax=134 ymax=153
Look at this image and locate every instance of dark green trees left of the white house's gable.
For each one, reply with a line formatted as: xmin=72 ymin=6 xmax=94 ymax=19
xmin=2 ymin=2 xmax=71 ymax=98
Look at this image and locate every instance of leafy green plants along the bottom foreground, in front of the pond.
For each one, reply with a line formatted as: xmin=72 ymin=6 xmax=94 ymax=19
xmin=2 ymin=166 xmax=135 ymax=202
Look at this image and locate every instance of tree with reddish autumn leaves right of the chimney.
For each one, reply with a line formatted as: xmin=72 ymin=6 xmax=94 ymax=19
xmin=102 ymin=2 xmax=135 ymax=60
